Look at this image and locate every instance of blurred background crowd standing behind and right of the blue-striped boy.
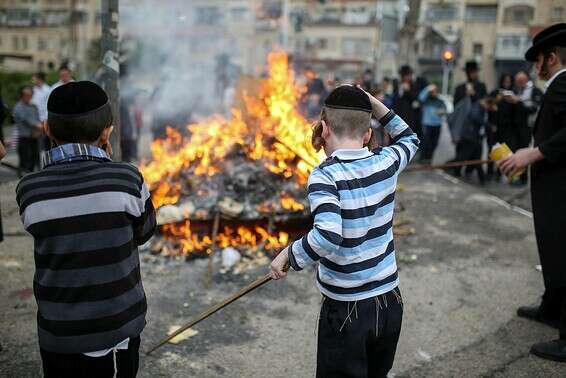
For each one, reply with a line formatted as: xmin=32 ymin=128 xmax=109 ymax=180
xmin=302 ymin=61 xmax=542 ymax=185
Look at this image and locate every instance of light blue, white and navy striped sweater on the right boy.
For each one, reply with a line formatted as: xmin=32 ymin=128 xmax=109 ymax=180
xmin=289 ymin=112 xmax=419 ymax=301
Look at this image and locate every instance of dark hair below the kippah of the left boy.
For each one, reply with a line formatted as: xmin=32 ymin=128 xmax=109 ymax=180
xmin=47 ymin=104 xmax=113 ymax=143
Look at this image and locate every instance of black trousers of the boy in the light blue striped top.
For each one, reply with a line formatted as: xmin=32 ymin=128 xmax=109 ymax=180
xmin=316 ymin=288 xmax=403 ymax=378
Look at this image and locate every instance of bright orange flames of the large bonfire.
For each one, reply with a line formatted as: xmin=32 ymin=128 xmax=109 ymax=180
xmin=140 ymin=52 xmax=320 ymax=253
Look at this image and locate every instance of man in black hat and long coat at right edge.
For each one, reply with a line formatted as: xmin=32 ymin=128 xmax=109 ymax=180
xmin=501 ymin=23 xmax=566 ymax=362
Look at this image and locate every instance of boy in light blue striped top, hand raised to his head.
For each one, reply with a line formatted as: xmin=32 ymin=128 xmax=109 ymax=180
xmin=271 ymin=86 xmax=419 ymax=378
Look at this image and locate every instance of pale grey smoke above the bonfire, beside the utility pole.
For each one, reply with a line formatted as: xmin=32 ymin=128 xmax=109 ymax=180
xmin=120 ymin=0 xmax=241 ymax=128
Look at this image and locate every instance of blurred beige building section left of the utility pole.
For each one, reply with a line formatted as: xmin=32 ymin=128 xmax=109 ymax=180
xmin=0 ymin=0 xmax=101 ymax=71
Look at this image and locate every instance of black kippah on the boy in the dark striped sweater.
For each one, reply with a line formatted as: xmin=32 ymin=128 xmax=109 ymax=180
xmin=47 ymin=81 xmax=108 ymax=116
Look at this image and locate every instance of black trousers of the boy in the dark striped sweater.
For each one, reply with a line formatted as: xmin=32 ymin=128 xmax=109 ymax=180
xmin=40 ymin=336 xmax=140 ymax=378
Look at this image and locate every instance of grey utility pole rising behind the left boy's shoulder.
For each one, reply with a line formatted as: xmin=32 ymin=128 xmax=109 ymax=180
xmin=100 ymin=0 xmax=122 ymax=161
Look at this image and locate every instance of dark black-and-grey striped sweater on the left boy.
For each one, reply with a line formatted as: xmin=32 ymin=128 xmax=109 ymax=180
xmin=16 ymin=145 xmax=155 ymax=353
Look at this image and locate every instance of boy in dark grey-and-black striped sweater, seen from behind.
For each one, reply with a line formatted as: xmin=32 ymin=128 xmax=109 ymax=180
xmin=16 ymin=81 xmax=156 ymax=378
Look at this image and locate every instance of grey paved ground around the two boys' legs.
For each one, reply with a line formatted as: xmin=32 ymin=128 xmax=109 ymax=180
xmin=0 ymin=173 xmax=566 ymax=378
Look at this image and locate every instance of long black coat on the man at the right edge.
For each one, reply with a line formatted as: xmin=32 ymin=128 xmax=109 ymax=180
xmin=531 ymin=73 xmax=566 ymax=289
